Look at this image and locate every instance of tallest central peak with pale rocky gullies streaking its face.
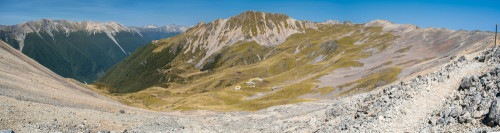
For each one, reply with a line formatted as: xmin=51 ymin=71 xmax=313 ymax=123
xmin=178 ymin=11 xmax=315 ymax=67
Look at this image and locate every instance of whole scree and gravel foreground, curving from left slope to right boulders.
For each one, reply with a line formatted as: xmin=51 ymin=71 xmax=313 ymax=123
xmin=0 ymin=24 xmax=500 ymax=132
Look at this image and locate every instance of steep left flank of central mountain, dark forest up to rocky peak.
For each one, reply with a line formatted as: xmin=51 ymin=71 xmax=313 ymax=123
xmin=101 ymin=11 xmax=314 ymax=91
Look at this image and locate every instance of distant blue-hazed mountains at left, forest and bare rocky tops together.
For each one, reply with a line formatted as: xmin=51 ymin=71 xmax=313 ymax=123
xmin=0 ymin=19 xmax=186 ymax=82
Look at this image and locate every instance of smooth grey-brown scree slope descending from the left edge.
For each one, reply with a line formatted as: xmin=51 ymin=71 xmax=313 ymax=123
xmin=0 ymin=41 xmax=126 ymax=111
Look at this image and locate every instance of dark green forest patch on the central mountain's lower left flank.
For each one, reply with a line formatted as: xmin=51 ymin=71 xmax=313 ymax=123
xmin=98 ymin=42 xmax=182 ymax=93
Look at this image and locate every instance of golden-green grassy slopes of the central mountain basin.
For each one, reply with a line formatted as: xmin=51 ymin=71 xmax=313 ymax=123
xmin=97 ymin=25 xmax=406 ymax=111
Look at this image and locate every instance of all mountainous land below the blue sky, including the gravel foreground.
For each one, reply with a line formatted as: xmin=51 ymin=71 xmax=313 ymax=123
xmin=0 ymin=11 xmax=500 ymax=133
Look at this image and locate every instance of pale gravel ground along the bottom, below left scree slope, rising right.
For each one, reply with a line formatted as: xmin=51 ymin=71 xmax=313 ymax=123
xmin=0 ymin=39 xmax=500 ymax=132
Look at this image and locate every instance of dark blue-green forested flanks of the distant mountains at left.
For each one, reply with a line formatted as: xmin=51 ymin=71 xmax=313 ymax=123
xmin=0 ymin=30 xmax=180 ymax=83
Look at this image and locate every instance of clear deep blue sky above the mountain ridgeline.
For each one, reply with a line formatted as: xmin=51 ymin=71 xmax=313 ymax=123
xmin=0 ymin=0 xmax=500 ymax=31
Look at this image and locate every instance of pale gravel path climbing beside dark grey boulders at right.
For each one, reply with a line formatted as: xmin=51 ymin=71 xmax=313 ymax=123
xmin=380 ymin=62 xmax=491 ymax=132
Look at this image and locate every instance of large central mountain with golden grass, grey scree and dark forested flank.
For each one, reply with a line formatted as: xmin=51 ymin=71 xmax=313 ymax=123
xmin=94 ymin=11 xmax=493 ymax=111
